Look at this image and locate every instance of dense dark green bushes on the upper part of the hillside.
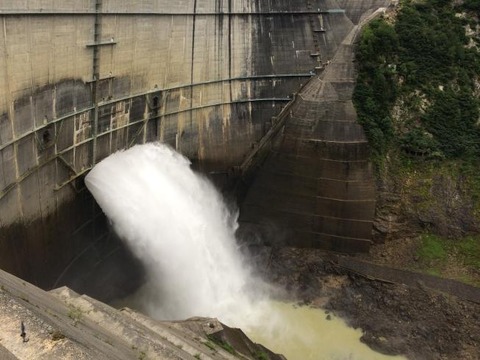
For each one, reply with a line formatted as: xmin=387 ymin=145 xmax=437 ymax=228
xmin=354 ymin=0 xmax=480 ymax=158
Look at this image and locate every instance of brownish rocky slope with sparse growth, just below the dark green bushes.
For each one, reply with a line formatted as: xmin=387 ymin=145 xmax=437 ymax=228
xmin=374 ymin=159 xmax=480 ymax=243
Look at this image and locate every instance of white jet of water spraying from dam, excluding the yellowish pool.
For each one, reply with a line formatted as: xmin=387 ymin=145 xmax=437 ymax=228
xmin=85 ymin=144 xmax=260 ymax=319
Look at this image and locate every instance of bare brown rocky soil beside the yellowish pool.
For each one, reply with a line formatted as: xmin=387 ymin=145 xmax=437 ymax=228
xmin=260 ymin=246 xmax=480 ymax=360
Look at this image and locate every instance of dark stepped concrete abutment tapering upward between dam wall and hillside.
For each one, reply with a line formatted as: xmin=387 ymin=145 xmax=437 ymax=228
xmin=240 ymin=17 xmax=375 ymax=252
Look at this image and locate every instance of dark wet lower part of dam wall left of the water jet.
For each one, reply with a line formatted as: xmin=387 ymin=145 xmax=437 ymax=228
xmin=0 ymin=187 xmax=142 ymax=301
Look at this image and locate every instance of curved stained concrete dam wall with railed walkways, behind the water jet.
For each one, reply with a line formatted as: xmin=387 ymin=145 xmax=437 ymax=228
xmin=0 ymin=0 xmax=385 ymax=298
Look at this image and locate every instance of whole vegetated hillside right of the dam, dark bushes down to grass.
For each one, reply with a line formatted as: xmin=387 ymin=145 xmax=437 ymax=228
xmin=353 ymin=0 xmax=480 ymax=286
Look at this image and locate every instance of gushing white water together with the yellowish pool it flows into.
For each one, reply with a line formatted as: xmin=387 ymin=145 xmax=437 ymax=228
xmin=85 ymin=144 xmax=404 ymax=359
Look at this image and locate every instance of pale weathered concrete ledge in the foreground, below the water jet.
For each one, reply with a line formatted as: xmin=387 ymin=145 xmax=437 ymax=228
xmin=0 ymin=270 xmax=285 ymax=360
